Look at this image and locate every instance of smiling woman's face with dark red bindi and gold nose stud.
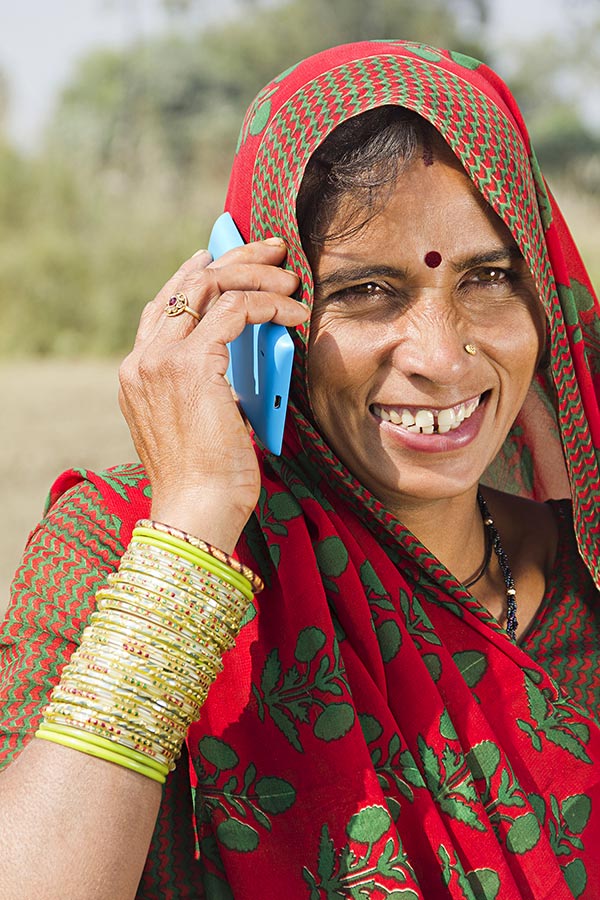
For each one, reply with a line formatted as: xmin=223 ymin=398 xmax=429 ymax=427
xmin=308 ymin=151 xmax=544 ymax=509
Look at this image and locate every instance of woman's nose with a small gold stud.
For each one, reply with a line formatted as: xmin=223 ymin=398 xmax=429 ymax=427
xmin=394 ymin=294 xmax=474 ymax=385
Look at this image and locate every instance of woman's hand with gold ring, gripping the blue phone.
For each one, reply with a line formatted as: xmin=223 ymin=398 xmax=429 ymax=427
xmin=120 ymin=238 xmax=307 ymax=552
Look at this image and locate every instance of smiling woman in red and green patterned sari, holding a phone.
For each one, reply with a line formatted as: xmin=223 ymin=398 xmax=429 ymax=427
xmin=0 ymin=42 xmax=600 ymax=900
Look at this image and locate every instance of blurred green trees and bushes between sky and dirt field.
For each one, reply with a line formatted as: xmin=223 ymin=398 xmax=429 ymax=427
xmin=0 ymin=0 xmax=600 ymax=356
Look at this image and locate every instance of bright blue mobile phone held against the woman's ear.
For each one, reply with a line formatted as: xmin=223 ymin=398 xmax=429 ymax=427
xmin=208 ymin=212 xmax=294 ymax=454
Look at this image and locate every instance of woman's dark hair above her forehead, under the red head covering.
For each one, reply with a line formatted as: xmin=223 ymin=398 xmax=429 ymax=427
xmin=296 ymin=106 xmax=442 ymax=264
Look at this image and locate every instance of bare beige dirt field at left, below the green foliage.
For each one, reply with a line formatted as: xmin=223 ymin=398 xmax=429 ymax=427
xmin=0 ymin=361 xmax=136 ymax=613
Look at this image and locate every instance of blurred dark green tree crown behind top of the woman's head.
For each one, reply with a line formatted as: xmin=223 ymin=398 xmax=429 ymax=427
xmin=51 ymin=0 xmax=487 ymax=190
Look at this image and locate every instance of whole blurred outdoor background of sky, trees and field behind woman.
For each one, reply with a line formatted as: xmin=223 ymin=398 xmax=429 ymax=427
xmin=0 ymin=0 xmax=600 ymax=610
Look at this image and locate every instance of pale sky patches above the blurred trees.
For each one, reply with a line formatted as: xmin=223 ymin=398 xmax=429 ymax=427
xmin=0 ymin=0 xmax=577 ymax=149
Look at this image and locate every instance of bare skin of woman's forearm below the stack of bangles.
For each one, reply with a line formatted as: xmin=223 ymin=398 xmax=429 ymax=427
xmin=0 ymin=739 xmax=161 ymax=900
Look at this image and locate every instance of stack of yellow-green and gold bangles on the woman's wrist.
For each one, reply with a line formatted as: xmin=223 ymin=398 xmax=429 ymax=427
xmin=35 ymin=519 xmax=263 ymax=783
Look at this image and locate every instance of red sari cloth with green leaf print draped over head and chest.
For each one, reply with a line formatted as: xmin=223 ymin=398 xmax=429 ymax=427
xmin=183 ymin=41 xmax=600 ymax=900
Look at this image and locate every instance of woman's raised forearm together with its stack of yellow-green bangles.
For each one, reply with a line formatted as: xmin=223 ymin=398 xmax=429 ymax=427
xmin=0 ymin=521 xmax=262 ymax=900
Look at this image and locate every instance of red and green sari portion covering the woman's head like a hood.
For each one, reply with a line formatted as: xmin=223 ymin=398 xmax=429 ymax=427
xmin=226 ymin=41 xmax=600 ymax=583
